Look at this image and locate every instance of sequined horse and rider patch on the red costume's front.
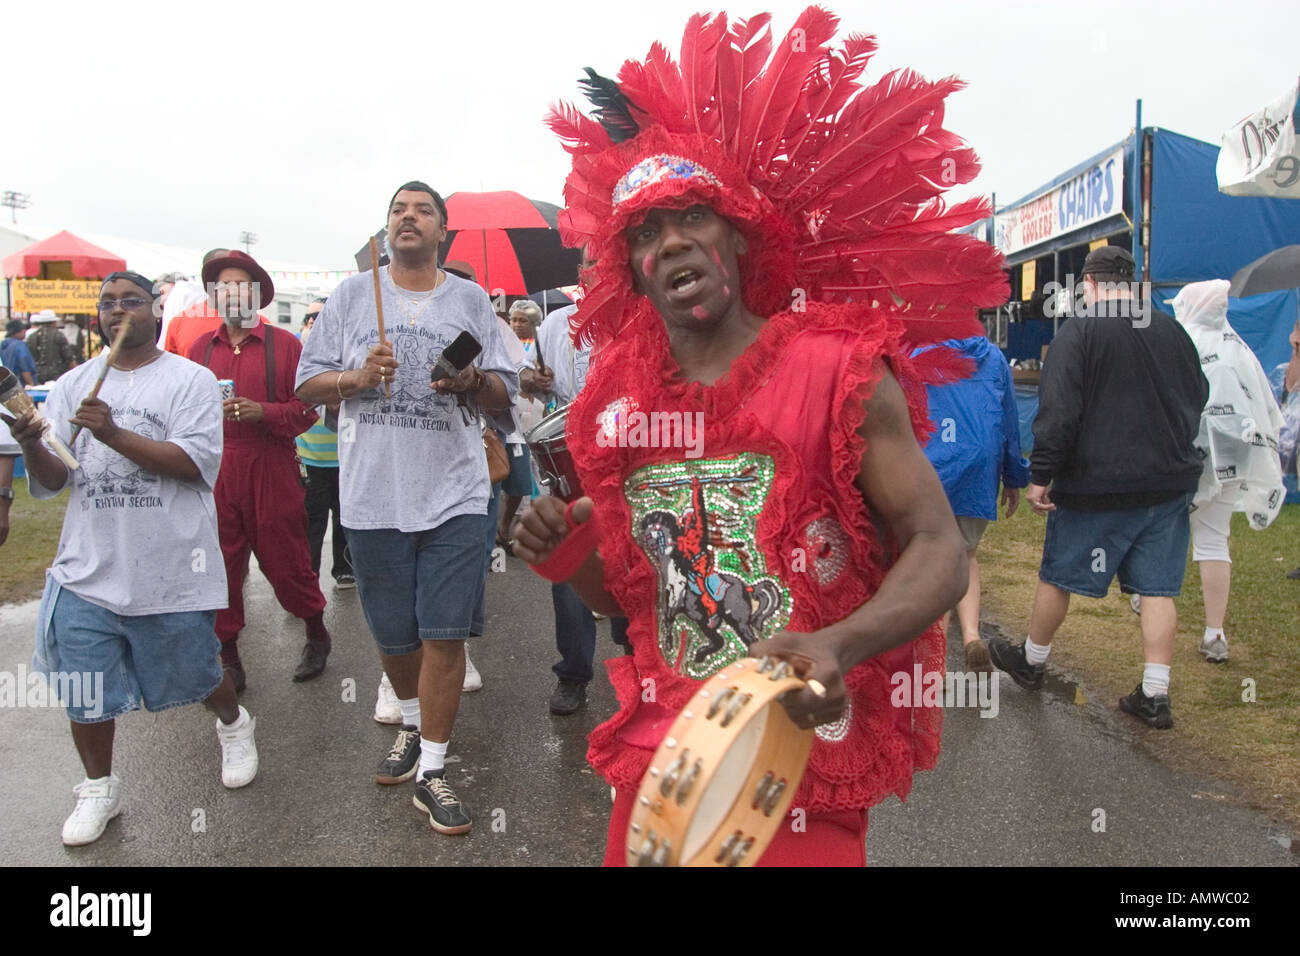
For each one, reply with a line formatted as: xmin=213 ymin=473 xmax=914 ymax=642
xmin=623 ymin=453 xmax=792 ymax=680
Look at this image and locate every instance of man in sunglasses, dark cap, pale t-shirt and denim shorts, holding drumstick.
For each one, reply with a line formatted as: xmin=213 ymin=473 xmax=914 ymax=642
xmin=8 ymin=272 xmax=257 ymax=845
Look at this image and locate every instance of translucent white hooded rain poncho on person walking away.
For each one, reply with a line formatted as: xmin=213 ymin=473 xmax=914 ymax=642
xmin=1170 ymin=278 xmax=1286 ymax=531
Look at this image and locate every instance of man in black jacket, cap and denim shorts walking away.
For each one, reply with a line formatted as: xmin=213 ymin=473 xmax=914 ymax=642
xmin=989 ymin=246 xmax=1209 ymax=728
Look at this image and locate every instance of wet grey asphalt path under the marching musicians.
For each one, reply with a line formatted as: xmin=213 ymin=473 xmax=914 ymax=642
xmin=0 ymin=546 xmax=1297 ymax=866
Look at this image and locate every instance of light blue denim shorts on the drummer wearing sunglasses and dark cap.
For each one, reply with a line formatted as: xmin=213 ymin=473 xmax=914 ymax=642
xmin=31 ymin=575 xmax=221 ymax=723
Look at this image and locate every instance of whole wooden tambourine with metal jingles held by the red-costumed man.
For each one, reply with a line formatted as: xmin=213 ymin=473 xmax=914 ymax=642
xmin=627 ymin=657 xmax=814 ymax=866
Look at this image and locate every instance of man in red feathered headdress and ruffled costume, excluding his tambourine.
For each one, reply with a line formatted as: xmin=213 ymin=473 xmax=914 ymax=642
xmin=516 ymin=8 xmax=1006 ymax=865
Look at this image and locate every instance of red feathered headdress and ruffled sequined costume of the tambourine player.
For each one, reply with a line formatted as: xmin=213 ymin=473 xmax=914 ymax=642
xmin=550 ymin=8 xmax=1006 ymax=861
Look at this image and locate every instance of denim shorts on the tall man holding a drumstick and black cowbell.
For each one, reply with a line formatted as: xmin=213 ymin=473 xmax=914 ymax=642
xmin=347 ymin=515 xmax=488 ymax=656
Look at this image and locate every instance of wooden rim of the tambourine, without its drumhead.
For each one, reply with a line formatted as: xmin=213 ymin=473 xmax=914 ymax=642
xmin=625 ymin=657 xmax=814 ymax=866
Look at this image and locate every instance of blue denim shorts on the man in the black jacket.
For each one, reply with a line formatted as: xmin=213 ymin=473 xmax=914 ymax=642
xmin=1039 ymin=494 xmax=1192 ymax=597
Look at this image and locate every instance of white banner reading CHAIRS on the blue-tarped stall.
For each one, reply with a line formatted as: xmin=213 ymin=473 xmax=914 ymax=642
xmin=995 ymin=147 xmax=1125 ymax=255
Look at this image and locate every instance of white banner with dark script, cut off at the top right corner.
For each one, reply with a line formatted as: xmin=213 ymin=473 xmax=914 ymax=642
xmin=1214 ymin=81 xmax=1300 ymax=199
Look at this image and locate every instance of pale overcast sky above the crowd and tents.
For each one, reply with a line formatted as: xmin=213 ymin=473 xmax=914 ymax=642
xmin=0 ymin=0 xmax=1300 ymax=268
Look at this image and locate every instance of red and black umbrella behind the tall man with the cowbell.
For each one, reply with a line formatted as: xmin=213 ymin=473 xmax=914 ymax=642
xmin=356 ymin=190 xmax=582 ymax=295
